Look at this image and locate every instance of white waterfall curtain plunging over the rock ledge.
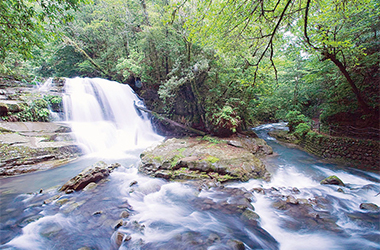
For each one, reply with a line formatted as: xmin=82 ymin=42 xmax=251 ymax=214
xmin=63 ymin=78 xmax=162 ymax=156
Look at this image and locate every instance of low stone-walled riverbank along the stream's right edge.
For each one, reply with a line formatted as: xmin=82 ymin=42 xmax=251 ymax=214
xmin=269 ymin=130 xmax=380 ymax=172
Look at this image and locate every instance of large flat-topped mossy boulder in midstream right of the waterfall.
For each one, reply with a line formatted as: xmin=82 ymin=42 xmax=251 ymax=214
xmin=139 ymin=137 xmax=269 ymax=182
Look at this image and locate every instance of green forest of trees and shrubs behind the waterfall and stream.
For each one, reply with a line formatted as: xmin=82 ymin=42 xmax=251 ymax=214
xmin=0 ymin=0 xmax=380 ymax=137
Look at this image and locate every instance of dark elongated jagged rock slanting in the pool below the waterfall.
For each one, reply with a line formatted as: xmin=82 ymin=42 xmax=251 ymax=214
xmin=59 ymin=161 xmax=120 ymax=192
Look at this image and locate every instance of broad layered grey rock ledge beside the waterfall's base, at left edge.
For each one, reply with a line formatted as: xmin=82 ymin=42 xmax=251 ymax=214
xmin=0 ymin=122 xmax=82 ymax=176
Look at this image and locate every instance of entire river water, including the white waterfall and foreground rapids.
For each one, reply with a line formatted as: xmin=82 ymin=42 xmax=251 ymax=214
xmin=0 ymin=78 xmax=380 ymax=250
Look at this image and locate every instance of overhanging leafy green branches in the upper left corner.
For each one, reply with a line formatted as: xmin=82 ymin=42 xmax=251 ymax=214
xmin=0 ymin=0 xmax=84 ymax=74
